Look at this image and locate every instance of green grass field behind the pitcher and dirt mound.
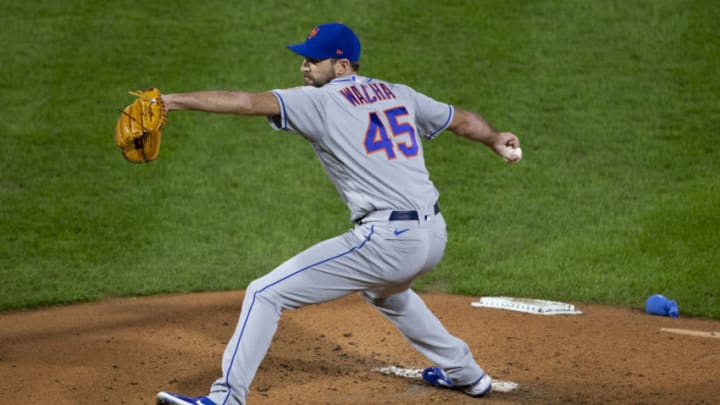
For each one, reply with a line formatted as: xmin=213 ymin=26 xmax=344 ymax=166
xmin=0 ymin=0 xmax=720 ymax=319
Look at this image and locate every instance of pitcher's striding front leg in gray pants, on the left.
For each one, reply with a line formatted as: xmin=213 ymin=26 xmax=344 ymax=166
xmin=209 ymin=227 xmax=370 ymax=405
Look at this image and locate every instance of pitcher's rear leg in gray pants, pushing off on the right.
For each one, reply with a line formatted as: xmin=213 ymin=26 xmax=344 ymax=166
xmin=364 ymin=289 xmax=484 ymax=385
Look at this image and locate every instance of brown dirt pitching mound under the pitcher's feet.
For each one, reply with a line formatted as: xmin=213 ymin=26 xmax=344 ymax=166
xmin=0 ymin=292 xmax=720 ymax=405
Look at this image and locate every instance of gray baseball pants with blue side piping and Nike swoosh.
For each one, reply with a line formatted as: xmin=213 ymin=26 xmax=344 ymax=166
xmin=209 ymin=210 xmax=483 ymax=405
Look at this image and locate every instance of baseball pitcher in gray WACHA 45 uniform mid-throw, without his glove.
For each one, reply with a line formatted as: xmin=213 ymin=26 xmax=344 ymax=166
xmin=152 ymin=23 xmax=521 ymax=405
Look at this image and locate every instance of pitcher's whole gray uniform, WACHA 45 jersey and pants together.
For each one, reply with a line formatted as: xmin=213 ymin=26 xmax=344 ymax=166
xmin=209 ymin=76 xmax=484 ymax=405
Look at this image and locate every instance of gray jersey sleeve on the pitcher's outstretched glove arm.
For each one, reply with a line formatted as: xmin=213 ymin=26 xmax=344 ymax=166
xmin=267 ymin=86 xmax=325 ymax=141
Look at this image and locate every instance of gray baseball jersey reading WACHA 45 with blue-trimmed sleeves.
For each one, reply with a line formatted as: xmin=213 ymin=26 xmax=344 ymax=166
xmin=271 ymin=76 xmax=453 ymax=221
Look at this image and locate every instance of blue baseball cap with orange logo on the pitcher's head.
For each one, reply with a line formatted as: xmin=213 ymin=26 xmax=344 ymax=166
xmin=288 ymin=22 xmax=360 ymax=62
